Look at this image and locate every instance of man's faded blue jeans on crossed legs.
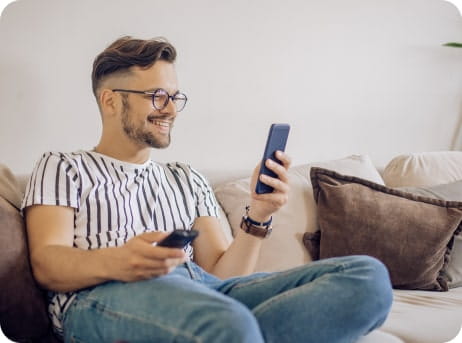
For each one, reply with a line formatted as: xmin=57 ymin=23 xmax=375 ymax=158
xmin=64 ymin=256 xmax=392 ymax=343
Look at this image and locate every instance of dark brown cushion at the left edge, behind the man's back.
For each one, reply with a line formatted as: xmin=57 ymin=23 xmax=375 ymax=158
xmin=0 ymin=197 xmax=50 ymax=341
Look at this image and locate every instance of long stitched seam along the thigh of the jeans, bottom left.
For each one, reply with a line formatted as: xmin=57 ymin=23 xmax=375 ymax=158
xmin=76 ymin=296 xmax=202 ymax=343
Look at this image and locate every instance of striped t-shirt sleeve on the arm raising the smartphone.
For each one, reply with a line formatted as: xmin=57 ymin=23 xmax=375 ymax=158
xmin=190 ymin=167 xmax=219 ymax=218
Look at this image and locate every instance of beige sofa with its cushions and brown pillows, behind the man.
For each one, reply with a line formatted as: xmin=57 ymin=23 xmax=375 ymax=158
xmin=0 ymin=151 xmax=462 ymax=343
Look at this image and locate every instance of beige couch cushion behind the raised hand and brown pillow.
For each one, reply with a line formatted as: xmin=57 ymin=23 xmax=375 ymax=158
xmin=215 ymin=156 xmax=383 ymax=271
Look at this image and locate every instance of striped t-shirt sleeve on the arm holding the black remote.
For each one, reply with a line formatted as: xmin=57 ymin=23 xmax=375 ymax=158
xmin=21 ymin=152 xmax=81 ymax=209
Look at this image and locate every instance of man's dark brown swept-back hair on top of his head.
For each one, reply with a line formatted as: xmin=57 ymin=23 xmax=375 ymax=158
xmin=91 ymin=36 xmax=176 ymax=97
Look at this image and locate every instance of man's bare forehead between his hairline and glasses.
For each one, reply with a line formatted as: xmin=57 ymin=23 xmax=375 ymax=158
xmin=130 ymin=61 xmax=178 ymax=93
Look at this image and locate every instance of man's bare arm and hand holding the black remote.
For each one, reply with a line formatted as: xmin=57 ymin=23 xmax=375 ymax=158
xmin=26 ymin=205 xmax=185 ymax=292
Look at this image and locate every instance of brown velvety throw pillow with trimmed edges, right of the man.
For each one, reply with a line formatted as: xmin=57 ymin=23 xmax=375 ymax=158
xmin=304 ymin=168 xmax=462 ymax=291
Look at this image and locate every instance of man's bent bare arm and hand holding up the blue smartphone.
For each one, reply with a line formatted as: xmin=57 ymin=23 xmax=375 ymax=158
xmin=194 ymin=153 xmax=290 ymax=278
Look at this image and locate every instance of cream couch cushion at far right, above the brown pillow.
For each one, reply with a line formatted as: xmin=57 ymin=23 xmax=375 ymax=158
xmin=382 ymin=151 xmax=462 ymax=187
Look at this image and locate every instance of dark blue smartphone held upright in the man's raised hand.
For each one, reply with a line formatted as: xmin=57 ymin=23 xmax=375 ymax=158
xmin=255 ymin=124 xmax=290 ymax=194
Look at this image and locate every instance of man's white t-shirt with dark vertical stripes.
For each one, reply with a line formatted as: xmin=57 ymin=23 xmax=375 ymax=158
xmin=22 ymin=151 xmax=218 ymax=335
